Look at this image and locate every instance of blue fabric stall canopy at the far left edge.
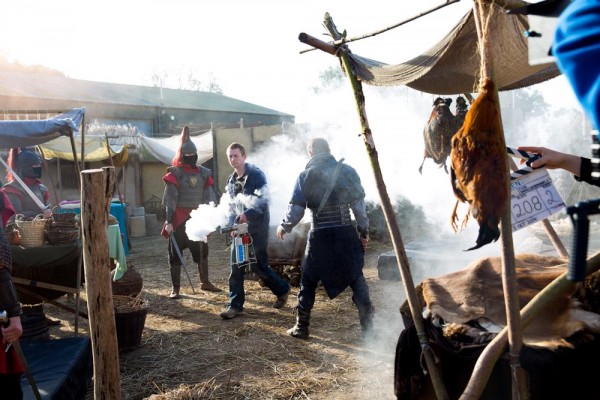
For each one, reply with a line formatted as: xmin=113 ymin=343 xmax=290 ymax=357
xmin=0 ymin=108 xmax=85 ymax=149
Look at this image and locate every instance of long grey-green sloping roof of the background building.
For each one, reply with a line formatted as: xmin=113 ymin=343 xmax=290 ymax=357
xmin=0 ymin=70 xmax=292 ymax=116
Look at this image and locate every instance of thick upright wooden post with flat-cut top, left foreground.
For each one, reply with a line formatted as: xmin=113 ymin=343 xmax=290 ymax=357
xmin=81 ymin=167 xmax=121 ymax=399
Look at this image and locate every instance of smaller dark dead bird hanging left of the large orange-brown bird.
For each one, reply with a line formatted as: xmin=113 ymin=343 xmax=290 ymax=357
xmin=419 ymin=97 xmax=459 ymax=174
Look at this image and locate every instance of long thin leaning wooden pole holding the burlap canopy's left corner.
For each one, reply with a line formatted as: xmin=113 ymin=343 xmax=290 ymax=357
xmin=324 ymin=13 xmax=449 ymax=400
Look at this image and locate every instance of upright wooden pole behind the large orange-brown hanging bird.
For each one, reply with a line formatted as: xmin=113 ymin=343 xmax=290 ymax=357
xmin=473 ymin=0 xmax=529 ymax=399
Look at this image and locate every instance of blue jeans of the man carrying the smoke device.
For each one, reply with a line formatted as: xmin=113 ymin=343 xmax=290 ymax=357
xmin=229 ymin=232 xmax=290 ymax=311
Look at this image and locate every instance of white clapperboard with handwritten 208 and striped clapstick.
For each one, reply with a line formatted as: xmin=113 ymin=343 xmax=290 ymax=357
xmin=506 ymin=147 xmax=565 ymax=232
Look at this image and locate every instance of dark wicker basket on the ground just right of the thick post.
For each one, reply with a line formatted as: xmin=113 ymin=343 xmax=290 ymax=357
xmin=113 ymin=295 xmax=148 ymax=353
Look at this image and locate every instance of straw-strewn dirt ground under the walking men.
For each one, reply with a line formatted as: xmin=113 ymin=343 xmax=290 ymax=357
xmin=45 ymin=233 xmax=405 ymax=400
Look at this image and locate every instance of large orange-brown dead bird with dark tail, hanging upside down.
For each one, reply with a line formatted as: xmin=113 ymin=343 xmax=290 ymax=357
xmin=450 ymin=79 xmax=509 ymax=250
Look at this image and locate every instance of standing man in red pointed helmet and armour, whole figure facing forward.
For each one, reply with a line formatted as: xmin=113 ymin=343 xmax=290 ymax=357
xmin=162 ymin=126 xmax=221 ymax=299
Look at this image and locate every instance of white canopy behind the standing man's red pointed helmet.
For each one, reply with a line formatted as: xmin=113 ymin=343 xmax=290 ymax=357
xmin=141 ymin=130 xmax=213 ymax=165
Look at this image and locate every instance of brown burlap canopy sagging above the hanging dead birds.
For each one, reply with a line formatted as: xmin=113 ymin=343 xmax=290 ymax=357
xmin=349 ymin=6 xmax=560 ymax=95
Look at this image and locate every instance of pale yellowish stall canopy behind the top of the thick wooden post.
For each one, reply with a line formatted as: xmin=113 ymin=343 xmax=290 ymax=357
xmin=39 ymin=135 xmax=126 ymax=161
